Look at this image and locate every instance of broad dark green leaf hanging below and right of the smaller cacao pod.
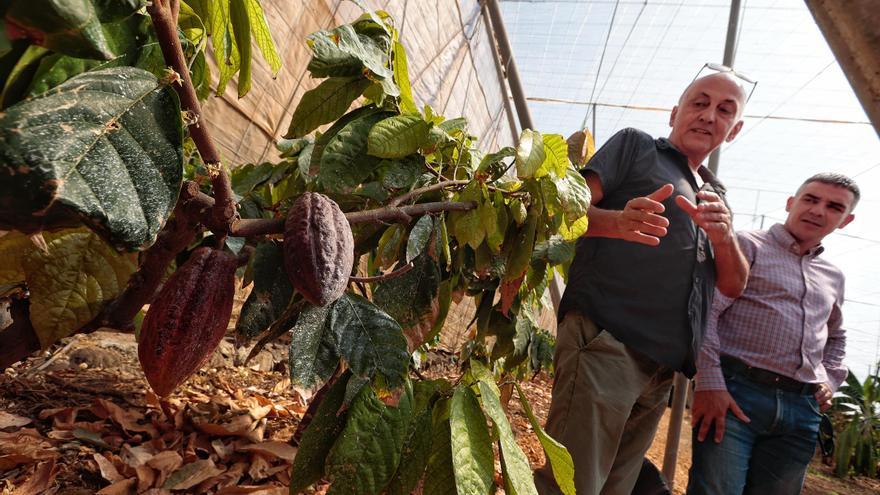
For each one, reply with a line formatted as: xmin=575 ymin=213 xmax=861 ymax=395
xmin=328 ymin=293 xmax=409 ymax=388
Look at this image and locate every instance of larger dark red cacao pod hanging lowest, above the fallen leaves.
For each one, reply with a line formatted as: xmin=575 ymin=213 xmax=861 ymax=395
xmin=138 ymin=247 xmax=238 ymax=397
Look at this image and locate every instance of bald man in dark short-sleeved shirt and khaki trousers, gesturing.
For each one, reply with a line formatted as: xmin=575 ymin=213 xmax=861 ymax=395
xmin=535 ymin=68 xmax=748 ymax=495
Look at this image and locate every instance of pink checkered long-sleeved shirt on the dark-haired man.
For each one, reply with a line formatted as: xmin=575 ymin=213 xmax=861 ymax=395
xmin=696 ymin=224 xmax=847 ymax=390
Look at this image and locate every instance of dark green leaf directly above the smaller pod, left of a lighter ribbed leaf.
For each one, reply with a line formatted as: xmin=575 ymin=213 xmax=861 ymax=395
xmin=312 ymin=112 xmax=387 ymax=193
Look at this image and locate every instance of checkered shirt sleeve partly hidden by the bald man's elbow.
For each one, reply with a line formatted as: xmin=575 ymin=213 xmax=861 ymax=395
xmin=695 ymin=233 xmax=756 ymax=392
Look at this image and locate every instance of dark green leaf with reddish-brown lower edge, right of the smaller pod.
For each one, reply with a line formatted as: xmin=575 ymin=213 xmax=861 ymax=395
xmin=373 ymin=253 xmax=440 ymax=351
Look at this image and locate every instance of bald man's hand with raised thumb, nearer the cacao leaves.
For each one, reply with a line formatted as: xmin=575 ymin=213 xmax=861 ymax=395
xmin=616 ymin=184 xmax=675 ymax=246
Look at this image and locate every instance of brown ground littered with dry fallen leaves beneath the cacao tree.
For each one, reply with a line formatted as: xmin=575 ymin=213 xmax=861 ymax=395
xmin=0 ymin=332 xmax=880 ymax=495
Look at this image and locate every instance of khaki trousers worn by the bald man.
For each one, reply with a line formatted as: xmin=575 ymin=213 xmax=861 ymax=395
xmin=535 ymin=312 xmax=673 ymax=495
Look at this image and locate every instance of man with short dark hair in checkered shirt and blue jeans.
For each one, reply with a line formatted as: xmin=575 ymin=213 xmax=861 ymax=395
xmin=688 ymin=173 xmax=859 ymax=495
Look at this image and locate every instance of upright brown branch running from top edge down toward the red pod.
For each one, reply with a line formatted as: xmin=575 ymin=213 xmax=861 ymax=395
xmin=147 ymin=0 xmax=235 ymax=236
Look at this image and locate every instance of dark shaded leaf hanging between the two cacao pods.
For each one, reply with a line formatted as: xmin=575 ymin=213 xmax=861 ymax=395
xmin=235 ymin=241 xmax=293 ymax=340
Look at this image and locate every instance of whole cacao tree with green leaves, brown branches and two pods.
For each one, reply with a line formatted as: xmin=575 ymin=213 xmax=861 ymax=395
xmin=0 ymin=0 xmax=590 ymax=494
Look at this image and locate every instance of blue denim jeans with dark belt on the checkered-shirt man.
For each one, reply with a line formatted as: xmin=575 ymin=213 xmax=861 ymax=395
xmin=687 ymin=370 xmax=822 ymax=495
